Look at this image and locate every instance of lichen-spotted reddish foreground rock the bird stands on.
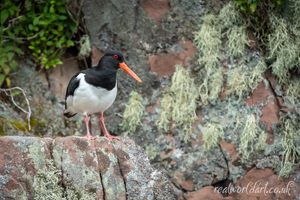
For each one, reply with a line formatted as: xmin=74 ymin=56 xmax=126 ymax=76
xmin=0 ymin=136 xmax=177 ymax=200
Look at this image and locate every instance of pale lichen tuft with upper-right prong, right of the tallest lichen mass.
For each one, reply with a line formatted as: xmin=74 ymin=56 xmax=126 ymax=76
xmin=227 ymin=59 xmax=267 ymax=100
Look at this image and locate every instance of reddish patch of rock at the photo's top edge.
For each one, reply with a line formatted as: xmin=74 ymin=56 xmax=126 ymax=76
xmin=141 ymin=0 xmax=170 ymax=26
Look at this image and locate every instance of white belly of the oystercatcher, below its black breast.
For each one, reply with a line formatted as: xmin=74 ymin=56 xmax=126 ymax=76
xmin=67 ymin=74 xmax=117 ymax=115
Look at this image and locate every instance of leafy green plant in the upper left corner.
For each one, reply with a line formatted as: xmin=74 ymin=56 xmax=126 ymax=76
xmin=0 ymin=0 xmax=76 ymax=85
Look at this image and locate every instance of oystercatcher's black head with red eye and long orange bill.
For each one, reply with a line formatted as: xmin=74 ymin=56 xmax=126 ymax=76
xmin=98 ymin=51 xmax=142 ymax=82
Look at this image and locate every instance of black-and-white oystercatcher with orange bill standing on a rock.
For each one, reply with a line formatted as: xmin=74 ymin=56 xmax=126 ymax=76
xmin=64 ymin=51 xmax=142 ymax=141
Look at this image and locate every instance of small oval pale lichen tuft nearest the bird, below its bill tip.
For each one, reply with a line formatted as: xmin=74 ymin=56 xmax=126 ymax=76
xmin=120 ymin=91 xmax=145 ymax=136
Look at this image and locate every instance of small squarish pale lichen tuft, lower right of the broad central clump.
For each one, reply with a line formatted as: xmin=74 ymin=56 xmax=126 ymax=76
xmin=202 ymin=124 xmax=224 ymax=150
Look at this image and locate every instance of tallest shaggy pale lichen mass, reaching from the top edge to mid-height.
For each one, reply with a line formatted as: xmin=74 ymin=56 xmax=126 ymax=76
xmin=194 ymin=2 xmax=249 ymax=105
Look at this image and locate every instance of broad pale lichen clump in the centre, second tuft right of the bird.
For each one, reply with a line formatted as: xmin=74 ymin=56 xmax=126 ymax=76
xmin=157 ymin=65 xmax=198 ymax=142
